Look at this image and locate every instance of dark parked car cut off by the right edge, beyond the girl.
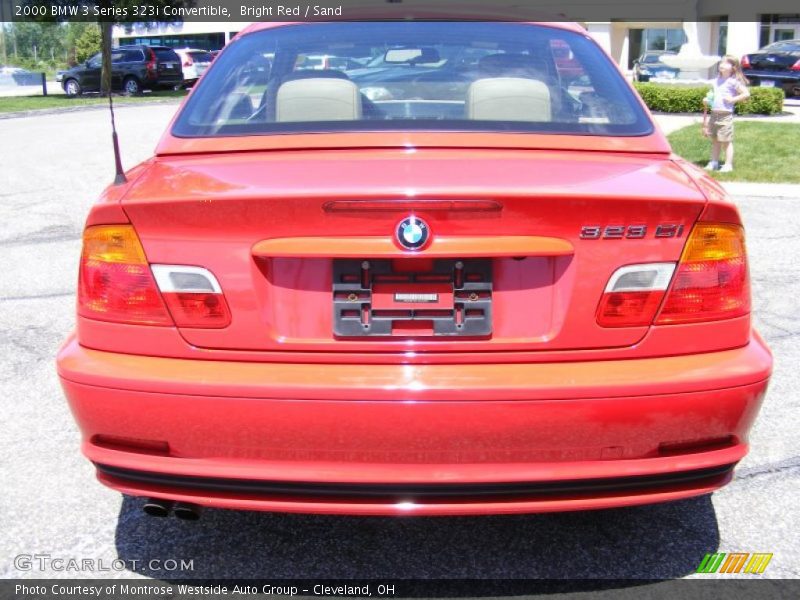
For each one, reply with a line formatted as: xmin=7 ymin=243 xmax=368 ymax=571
xmin=742 ymin=40 xmax=800 ymax=97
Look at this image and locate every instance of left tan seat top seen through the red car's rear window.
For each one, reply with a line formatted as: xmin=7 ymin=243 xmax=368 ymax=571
xmin=275 ymin=77 xmax=361 ymax=123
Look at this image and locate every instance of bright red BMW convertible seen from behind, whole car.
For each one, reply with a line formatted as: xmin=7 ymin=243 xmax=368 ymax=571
xmin=58 ymin=21 xmax=772 ymax=515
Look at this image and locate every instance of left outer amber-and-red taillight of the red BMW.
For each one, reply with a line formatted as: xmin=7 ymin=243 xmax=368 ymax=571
xmin=78 ymin=225 xmax=172 ymax=325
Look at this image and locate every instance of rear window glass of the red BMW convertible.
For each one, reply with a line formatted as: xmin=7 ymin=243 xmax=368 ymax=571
xmin=173 ymin=22 xmax=652 ymax=137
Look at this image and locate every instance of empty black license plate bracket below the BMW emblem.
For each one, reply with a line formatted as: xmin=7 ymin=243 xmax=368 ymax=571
xmin=333 ymin=259 xmax=492 ymax=338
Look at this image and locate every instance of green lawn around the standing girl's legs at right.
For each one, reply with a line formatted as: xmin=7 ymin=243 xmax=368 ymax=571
xmin=669 ymin=121 xmax=800 ymax=183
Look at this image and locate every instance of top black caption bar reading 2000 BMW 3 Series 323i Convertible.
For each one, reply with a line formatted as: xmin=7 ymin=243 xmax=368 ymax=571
xmin=0 ymin=0 xmax=800 ymax=23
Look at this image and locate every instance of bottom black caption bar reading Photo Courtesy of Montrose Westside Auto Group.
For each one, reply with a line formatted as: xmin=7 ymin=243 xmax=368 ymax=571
xmin=0 ymin=576 xmax=800 ymax=600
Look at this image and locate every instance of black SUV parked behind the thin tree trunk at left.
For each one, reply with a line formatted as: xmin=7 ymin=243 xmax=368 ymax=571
xmin=61 ymin=46 xmax=183 ymax=96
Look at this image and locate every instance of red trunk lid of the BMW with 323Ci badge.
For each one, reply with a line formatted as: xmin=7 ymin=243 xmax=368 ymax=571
xmin=123 ymin=149 xmax=705 ymax=353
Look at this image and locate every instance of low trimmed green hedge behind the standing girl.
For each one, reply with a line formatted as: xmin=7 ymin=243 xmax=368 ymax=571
xmin=634 ymin=83 xmax=783 ymax=115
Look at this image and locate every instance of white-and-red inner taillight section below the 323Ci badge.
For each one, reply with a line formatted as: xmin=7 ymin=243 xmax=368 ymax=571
xmin=597 ymin=263 xmax=675 ymax=327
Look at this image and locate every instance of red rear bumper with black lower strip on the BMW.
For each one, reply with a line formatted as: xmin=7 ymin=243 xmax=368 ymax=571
xmin=58 ymin=337 xmax=772 ymax=515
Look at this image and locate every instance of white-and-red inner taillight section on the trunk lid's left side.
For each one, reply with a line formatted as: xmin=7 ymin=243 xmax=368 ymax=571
xmin=152 ymin=265 xmax=231 ymax=329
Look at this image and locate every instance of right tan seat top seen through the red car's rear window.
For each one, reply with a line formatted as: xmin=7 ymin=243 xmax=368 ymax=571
xmin=466 ymin=77 xmax=553 ymax=122
